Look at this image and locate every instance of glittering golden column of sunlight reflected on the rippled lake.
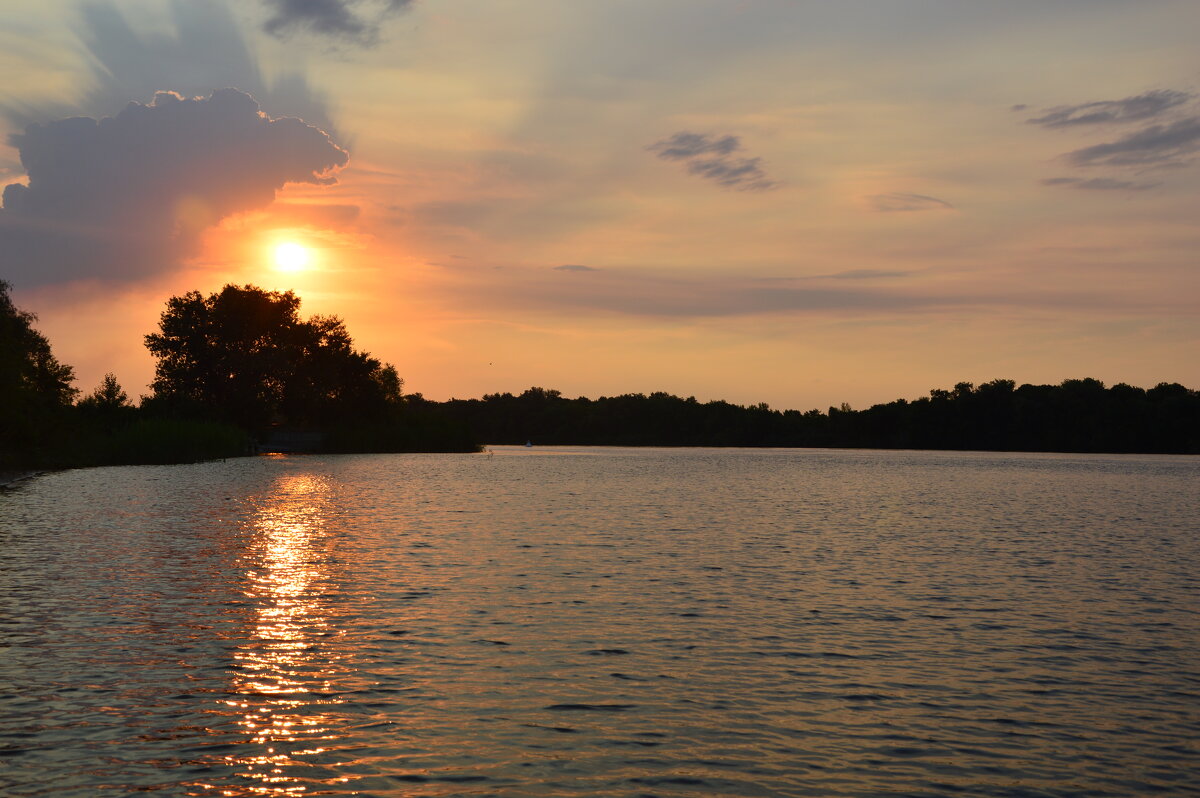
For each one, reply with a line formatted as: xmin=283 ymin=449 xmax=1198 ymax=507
xmin=209 ymin=474 xmax=349 ymax=796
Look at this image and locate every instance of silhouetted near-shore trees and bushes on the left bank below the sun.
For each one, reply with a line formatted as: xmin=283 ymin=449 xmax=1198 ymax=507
xmin=0 ymin=281 xmax=478 ymax=472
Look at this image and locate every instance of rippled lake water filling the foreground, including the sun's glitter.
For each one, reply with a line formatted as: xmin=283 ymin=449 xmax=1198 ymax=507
xmin=0 ymin=448 xmax=1200 ymax=798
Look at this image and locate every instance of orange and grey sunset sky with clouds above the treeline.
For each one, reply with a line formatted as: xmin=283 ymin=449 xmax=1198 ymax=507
xmin=0 ymin=0 xmax=1200 ymax=409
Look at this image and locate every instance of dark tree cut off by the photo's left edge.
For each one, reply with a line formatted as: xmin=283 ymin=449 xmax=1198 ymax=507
xmin=0 ymin=280 xmax=79 ymax=464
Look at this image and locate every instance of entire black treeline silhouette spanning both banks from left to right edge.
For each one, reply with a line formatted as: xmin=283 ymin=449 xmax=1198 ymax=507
xmin=0 ymin=281 xmax=1200 ymax=472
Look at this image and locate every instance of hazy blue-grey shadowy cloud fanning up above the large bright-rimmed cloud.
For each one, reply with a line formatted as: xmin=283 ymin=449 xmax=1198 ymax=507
xmin=0 ymin=0 xmax=342 ymax=140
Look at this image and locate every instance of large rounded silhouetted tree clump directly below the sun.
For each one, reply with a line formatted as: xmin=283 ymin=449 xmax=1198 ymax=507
xmin=145 ymin=284 xmax=400 ymax=430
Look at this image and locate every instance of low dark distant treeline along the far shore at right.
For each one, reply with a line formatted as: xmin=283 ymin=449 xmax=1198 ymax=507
xmin=443 ymin=379 xmax=1200 ymax=454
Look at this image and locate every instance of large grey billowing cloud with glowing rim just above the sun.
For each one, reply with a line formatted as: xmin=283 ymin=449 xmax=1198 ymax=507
xmin=0 ymin=89 xmax=348 ymax=284
